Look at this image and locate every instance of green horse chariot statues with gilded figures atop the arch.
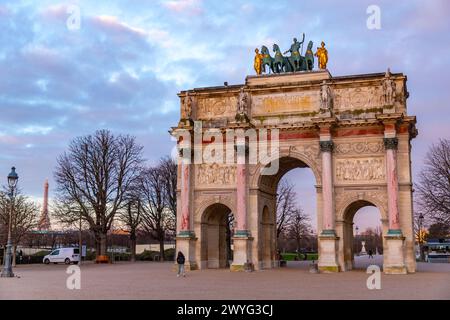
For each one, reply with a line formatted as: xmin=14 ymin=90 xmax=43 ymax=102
xmin=253 ymin=34 xmax=328 ymax=75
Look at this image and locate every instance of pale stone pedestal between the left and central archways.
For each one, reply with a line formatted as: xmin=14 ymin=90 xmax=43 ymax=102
xmin=230 ymin=230 xmax=254 ymax=271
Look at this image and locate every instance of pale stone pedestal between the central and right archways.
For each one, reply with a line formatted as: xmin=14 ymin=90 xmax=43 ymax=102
xmin=318 ymin=230 xmax=340 ymax=272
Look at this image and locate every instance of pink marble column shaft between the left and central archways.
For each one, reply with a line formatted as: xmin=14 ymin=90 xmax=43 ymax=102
xmin=236 ymin=154 xmax=247 ymax=230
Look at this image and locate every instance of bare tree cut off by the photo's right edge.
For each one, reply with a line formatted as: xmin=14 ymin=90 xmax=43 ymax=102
xmin=416 ymin=139 xmax=450 ymax=226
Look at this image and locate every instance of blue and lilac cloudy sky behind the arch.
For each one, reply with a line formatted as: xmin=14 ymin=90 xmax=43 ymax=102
xmin=0 ymin=0 xmax=450 ymax=230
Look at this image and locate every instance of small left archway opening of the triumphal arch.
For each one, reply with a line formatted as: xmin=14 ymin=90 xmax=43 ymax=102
xmin=201 ymin=203 xmax=234 ymax=269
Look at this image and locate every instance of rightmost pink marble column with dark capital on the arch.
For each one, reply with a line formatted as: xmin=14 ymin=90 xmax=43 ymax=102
xmin=384 ymin=138 xmax=400 ymax=230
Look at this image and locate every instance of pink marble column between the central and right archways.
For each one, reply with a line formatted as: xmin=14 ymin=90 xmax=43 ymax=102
xmin=320 ymin=141 xmax=334 ymax=233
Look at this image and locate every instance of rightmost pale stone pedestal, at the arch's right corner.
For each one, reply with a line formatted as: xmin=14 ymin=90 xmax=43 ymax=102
xmin=383 ymin=232 xmax=407 ymax=274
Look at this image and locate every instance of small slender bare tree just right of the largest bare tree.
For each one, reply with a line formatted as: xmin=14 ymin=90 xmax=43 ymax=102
xmin=118 ymin=197 xmax=142 ymax=262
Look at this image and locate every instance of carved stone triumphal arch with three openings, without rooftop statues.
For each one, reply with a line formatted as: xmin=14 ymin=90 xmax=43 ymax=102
xmin=171 ymin=70 xmax=417 ymax=274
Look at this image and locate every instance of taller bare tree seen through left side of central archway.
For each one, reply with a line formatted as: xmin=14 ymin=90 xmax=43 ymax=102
xmin=276 ymin=180 xmax=297 ymax=238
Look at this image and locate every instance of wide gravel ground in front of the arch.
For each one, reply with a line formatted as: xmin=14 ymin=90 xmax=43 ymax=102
xmin=0 ymin=257 xmax=450 ymax=300
